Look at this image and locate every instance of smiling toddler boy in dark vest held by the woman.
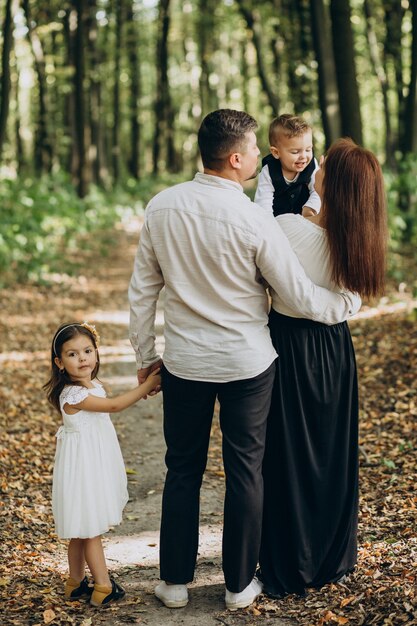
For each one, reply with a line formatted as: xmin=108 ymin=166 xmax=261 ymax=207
xmin=255 ymin=114 xmax=321 ymax=217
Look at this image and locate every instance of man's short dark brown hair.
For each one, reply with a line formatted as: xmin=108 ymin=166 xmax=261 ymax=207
xmin=198 ymin=109 xmax=258 ymax=170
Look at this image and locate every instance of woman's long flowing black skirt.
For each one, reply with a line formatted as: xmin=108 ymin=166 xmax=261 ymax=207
xmin=260 ymin=310 xmax=358 ymax=597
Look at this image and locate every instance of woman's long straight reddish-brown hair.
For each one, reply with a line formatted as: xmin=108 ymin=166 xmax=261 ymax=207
xmin=322 ymin=138 xmax=387 ymax=298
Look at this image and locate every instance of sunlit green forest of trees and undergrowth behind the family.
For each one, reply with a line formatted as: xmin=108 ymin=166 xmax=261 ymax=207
xmin=0 ymin=0 xmax=417 ymax=284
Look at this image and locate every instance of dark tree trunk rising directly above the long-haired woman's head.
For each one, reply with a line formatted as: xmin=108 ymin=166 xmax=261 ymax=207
xmin=330 ymin=0 xmax=362 ymax=144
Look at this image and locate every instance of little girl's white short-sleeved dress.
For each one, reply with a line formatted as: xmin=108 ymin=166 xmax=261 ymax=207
xmin=52 ymin=381 xmax=129 ymax=539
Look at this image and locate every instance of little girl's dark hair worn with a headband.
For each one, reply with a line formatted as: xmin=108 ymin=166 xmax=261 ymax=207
xmin=43 ymin=323 xmax=100 ymax=413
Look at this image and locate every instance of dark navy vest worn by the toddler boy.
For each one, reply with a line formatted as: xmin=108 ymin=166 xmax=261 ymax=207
xmin=262 ymin=154 xmax=316 ymax=216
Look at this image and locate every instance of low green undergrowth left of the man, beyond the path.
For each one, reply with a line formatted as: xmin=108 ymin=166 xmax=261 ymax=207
xmin=0 ymin=174 xmax=182 ymax=285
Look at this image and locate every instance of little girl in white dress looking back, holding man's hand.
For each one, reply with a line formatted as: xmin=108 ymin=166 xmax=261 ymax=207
xmin=44 ymin=323 xmax=161 ymax=606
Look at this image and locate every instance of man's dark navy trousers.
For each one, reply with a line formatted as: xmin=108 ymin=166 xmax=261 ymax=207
xmin=160 ymin=363 xmax=275 ymax=593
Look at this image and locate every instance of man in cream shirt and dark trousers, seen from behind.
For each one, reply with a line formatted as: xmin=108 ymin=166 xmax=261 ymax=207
xmin=129 ymin=109 xmax=360 ymax=609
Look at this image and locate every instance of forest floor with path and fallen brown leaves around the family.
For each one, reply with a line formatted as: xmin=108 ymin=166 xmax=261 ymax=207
xmin=0 ymin=218 xmax=417 ymax=626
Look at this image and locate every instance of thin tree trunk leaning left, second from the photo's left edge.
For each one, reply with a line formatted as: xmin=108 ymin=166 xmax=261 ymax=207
xmin=22 ymin=0 xmax=52 ymax=173
